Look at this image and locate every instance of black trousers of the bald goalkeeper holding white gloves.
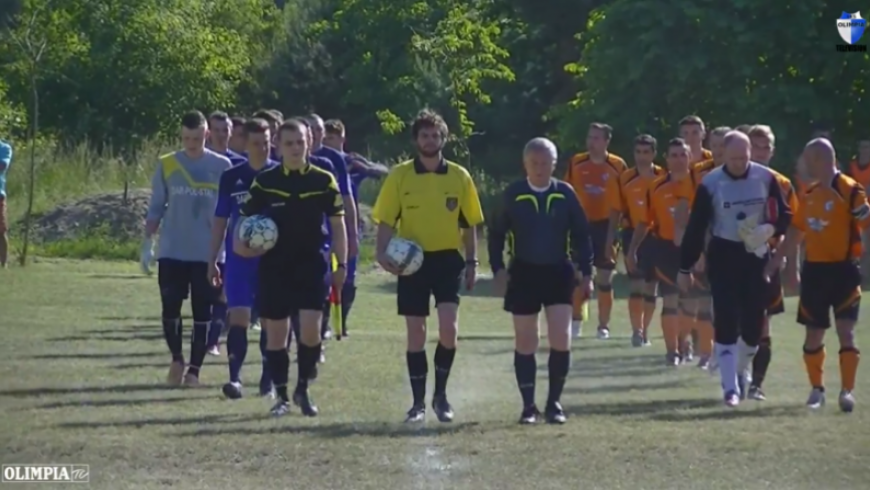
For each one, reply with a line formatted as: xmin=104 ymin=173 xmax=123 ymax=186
xmin=707 ymin=238 xmax=770 ymax=346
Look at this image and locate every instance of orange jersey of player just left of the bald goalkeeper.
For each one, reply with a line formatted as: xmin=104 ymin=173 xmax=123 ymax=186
xmin=642 ymin=173 xmax=695 ymax=240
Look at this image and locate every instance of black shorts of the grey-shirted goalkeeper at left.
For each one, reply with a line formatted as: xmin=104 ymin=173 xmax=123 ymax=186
xmin=157 ymin=259 xmax=221 ymax=322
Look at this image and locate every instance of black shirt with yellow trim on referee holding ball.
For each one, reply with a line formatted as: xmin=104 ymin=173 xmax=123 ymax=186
xmin=241 ymin=163 xmax=344 ymax=257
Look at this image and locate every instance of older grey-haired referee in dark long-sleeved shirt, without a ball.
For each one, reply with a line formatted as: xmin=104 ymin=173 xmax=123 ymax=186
xmin=489 ymin=138 xmax=592 ymax=424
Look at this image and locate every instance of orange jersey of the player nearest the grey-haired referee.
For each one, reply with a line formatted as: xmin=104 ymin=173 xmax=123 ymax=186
xmin=564 ymin=153 xmax=628 ymax=221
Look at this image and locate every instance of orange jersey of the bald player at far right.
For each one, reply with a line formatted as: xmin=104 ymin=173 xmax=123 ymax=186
xmin=792 ymin=173 xmax=870 ymax=262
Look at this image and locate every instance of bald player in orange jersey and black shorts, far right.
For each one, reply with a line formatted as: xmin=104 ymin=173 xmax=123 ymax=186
xmin=766 ymin=138 xmax=870 ymax=412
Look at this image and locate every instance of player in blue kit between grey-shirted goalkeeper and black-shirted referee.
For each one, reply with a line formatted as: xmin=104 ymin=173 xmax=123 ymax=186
xmin=209 ymin=119 xmax=277 ymax=399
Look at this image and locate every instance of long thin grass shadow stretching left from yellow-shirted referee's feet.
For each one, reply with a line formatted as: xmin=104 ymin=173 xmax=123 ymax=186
xmin=172 ymin=422 xmax=482 ymax=439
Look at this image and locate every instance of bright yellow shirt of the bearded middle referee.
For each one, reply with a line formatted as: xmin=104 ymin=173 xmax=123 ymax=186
xmin=372 ymin=159 xmax=483 ymax=252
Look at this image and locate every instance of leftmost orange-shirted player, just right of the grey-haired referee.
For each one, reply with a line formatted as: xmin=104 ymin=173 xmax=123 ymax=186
xmin=565 ymin=123 xmax=627 ymax=339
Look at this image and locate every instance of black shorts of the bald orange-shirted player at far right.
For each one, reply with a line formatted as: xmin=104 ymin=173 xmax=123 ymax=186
xmin=797 ymin=262 xmax=861 ymax=328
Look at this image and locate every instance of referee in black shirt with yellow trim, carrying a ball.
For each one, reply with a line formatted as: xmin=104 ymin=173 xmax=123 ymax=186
xmin=233 ymin=120 xmax=347 ymax=417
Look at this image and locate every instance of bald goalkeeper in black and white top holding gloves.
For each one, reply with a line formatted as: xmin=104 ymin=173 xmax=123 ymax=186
xmin=677 ymin=131 xmax=792 ymax=407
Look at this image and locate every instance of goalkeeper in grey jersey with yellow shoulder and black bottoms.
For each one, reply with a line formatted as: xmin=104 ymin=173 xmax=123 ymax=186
xmin=141 ymin=111 xmax=231 ymax=386
